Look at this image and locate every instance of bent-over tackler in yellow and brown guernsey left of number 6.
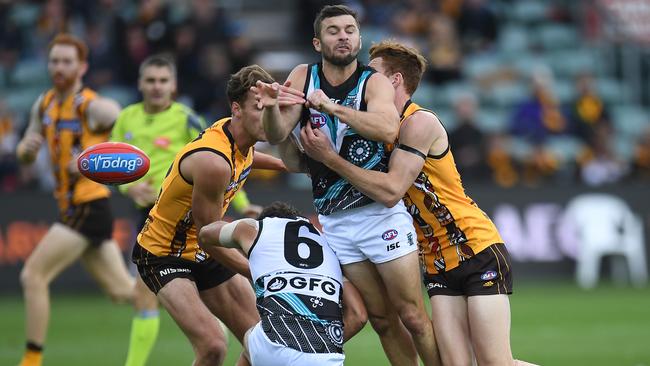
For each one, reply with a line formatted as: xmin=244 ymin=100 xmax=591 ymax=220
xmin=132 ymin=65 xmax=294 ymax=365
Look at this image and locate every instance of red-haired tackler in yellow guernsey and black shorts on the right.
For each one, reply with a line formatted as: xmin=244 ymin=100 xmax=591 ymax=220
xmin=301 ymin=41 xmax=525 ymax=365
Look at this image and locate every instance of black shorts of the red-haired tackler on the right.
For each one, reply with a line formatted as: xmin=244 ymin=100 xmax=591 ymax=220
xmin=424 ymin=244 xmax=512 ymax=297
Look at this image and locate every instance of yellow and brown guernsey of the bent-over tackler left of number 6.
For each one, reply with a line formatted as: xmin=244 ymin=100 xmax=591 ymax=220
xmin=138 ymin=118 xmax=253 ymax=262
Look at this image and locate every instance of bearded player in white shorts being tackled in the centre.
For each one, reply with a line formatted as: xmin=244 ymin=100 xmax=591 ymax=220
xmin=251 ymin=5 xmax=440 ymax=365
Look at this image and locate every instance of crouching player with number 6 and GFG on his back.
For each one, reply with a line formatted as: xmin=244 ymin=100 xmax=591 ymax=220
xmin=199 ymin=202 xmax=345 ymax=366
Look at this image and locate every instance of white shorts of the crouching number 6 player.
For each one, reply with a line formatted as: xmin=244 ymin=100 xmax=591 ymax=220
xmin=247 ymin=323 xmax=345 ymax=366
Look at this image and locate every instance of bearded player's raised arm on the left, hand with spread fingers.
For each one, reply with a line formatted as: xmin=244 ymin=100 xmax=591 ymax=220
xmin=251 ymin=65 xmax=307 ymax=145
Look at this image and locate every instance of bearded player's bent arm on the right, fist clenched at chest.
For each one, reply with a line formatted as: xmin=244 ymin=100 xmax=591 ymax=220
xmin=307 ymin=73 xmax=399 ymax=144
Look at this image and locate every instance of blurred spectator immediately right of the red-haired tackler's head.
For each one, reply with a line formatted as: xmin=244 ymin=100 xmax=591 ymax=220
xmin=427 ymin=14 xmax=463 ymax=84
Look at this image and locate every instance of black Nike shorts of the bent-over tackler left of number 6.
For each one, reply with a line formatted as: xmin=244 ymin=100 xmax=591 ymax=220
xmin=132 ymin=243 xmax=235 ymax=294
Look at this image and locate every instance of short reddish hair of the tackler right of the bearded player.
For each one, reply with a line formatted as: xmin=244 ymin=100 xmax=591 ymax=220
xmin=368 ymin=41 xmax=427 ymax=95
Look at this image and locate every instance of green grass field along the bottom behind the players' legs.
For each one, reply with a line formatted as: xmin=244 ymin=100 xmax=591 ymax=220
xmin=0 ymin=283 xmax=650 ymax=366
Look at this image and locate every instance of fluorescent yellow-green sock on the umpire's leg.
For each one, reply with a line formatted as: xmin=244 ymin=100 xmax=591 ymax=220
xmin=126 ymin=311 xmax=160 ymax=366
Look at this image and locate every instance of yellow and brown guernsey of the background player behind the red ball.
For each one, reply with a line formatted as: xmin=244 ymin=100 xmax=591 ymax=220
xmin=39 ymin=88 xmax=110 ymax=214
